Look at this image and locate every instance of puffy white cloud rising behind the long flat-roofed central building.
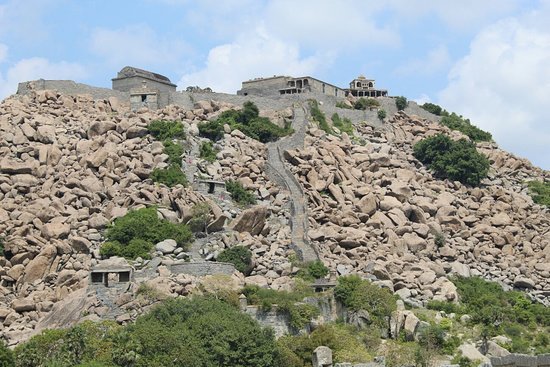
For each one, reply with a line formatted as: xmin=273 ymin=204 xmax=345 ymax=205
xmin=178 ymin=28 xmax=332 ymax=93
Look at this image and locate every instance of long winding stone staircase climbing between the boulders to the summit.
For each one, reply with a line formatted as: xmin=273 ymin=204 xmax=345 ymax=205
xmin=266 ymin=104 xmax=319 ymax=261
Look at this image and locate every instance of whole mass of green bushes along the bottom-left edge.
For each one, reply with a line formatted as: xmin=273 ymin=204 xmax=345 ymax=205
xmin=15 ymin=297 xmax=282 ymax=367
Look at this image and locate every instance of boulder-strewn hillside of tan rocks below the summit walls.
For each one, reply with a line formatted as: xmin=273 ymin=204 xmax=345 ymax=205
xmin=0 ymin=87 xmax=550 ymax=343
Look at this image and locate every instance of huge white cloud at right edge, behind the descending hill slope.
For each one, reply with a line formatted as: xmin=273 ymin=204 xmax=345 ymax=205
xmin=439 ymin=8 xmax=550 ymax=169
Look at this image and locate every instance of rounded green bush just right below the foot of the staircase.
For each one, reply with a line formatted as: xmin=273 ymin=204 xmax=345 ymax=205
xmin=334 ymin=275 xmax=397 ymax=326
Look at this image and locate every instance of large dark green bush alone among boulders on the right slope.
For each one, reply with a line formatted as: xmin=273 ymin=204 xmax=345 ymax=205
xmin=414 ymin=134 xmax=489 ymax=186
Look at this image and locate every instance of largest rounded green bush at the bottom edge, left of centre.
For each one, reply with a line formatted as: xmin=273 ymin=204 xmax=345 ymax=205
xmin=114 ymin=297 xmax=278 ymax=367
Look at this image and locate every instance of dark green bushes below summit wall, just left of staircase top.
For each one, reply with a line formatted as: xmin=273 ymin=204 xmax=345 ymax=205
xmin=199 ymin=101 xmax=293 ymax=143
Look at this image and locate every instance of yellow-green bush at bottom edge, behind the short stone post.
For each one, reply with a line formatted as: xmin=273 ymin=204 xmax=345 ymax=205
xmin=278 ymin=324 xmax=372 ymax=367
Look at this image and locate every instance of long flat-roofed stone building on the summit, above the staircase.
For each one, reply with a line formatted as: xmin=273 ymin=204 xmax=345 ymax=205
xmin=237 ymin=76 xmax=345 ymax=97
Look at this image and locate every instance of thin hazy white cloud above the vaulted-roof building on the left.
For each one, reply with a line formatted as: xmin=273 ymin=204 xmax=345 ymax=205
xmin=91 ymin=25 xmax=194 ymax=68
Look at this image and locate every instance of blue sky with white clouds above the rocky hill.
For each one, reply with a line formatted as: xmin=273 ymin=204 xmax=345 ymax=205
xmin=0 ymin=0 xmax=550 ymax=170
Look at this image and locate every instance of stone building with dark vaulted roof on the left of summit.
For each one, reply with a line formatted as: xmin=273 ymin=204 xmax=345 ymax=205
xmin=112 ymin=66 xmax=176 ymax=110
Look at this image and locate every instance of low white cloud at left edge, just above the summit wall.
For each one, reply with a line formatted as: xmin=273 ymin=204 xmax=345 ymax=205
xmin=0 ymin=57 xmax=87 ymax=99
